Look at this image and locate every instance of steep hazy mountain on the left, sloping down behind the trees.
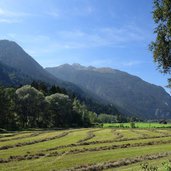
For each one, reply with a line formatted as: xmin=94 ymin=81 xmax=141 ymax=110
xmin=0 ymin=40 xmax=118 ymax=114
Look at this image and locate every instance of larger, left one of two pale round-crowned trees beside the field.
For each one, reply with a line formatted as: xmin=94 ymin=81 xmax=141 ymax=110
xmin=16 ymin=85 xmax=44 ymax=127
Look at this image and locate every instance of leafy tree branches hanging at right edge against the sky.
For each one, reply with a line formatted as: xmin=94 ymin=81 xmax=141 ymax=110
xmin=150 ymin=0 xmax=171 ymax=85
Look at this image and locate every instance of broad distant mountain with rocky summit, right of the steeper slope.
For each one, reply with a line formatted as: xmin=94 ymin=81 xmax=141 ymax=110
xmin=46 ymin=64 xmax=171 ymax=119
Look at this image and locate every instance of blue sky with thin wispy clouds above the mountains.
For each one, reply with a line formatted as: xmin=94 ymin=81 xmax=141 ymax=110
xmin=0 ymin=0 xmax=170 ymax=92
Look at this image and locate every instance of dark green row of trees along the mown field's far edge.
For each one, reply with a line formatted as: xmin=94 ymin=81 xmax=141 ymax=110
xmin=0 ymin=81 xmax=128 ymax=130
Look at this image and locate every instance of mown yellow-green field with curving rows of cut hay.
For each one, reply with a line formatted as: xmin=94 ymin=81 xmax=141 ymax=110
xmin=0 ymin=127 xmax=171 ymax=171
